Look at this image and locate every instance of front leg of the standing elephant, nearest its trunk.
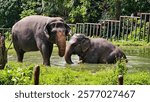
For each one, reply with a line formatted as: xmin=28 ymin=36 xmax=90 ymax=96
xmin=40 ymin=44 xmax=53 ymax=66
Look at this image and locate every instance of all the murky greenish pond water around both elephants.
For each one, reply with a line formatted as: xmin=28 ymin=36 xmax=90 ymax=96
xmin=8 ymin=46 xmax=150 ymax=71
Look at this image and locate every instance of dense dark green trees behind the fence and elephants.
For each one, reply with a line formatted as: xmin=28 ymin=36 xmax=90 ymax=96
xmin=0 ymin=0 xmax=150 ymax=27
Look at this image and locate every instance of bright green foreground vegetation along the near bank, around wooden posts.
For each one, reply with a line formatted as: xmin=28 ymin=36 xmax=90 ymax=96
xmin=0 ymin=62 xmax=150 ymax=85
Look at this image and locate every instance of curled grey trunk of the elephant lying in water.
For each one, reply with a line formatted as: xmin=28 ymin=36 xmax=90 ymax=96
xmin=65 ymin=45 xmax=73 ymax=64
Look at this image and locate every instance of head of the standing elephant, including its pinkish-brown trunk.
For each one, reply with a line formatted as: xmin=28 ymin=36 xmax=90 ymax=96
xmin=44 ymin=17 xmax=70 ymax=57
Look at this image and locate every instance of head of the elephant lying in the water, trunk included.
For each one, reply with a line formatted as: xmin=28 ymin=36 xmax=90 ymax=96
xmin=65 ymin=34 xmax=91 ymax=64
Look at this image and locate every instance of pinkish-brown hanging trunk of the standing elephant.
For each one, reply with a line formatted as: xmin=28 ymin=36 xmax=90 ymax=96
xmin=56 ymin=31 xmax=66 ymax=57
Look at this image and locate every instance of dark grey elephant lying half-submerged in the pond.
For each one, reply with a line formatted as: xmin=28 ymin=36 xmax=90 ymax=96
xmin=65 ymin=34 xmax=127 ymax=64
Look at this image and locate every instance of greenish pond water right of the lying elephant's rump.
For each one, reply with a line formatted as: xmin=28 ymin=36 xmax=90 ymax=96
xmin=122 ymin=46 xmax=150 ymax=71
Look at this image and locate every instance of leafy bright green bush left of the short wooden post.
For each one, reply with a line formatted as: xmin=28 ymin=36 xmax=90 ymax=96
xmin=0 ymin=62 xmax=33 ymax=85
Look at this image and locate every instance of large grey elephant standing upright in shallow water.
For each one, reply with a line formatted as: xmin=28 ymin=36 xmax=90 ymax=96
xmin=12 ymin=15 xmax=70 ymax=66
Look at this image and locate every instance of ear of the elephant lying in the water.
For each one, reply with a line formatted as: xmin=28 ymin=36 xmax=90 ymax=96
xmin=81 ymin=38 xmax=91 ymax=52
